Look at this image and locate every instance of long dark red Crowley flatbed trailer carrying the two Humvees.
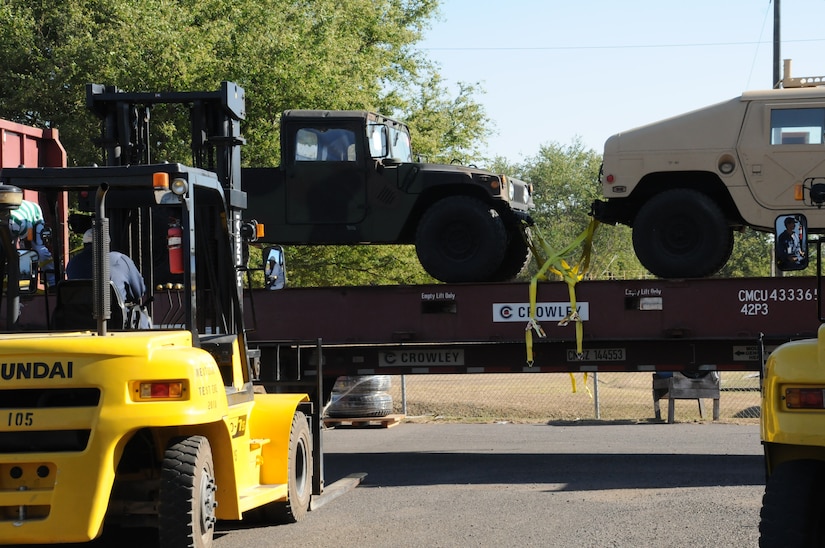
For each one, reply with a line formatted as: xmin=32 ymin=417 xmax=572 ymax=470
xmin=238 ymin=277 xmax=817 ymax=387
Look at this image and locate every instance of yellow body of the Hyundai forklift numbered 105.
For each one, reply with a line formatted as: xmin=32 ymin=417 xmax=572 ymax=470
xmin=0 ymin=331 xmax=308 ymax=544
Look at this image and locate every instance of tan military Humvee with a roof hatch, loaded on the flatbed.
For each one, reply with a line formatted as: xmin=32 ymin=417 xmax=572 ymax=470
xmin=593 ymin=60 xmax=825 ymax=278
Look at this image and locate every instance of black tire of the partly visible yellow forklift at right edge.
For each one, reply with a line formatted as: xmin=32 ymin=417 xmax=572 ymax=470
xmin=759 ymin=460 xmax=825 ymax=548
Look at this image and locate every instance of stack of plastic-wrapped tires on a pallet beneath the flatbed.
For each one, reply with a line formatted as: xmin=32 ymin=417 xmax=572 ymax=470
xmin=327 ymin=375 xmax=392 ymax=418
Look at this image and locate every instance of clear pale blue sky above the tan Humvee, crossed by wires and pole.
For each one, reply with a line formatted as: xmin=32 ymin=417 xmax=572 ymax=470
xmin=421 ymin=0 xmax=825 ymax=161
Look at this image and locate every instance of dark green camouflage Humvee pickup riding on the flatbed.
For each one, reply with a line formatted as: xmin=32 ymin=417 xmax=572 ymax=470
xmin=241 ymin=110 xmax=533 ymax=282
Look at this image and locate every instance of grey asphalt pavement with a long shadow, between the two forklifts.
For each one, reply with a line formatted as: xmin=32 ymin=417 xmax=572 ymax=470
xmin=215 ymin=422 xmax=764 ymax=548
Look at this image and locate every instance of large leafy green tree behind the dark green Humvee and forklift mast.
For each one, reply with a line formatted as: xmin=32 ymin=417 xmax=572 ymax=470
xmin=0 ymin=0 xmax=502 ymax=285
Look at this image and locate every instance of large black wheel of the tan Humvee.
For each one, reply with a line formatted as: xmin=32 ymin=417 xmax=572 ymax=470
xmin=633 ymin=188 xmax=733 ymax=278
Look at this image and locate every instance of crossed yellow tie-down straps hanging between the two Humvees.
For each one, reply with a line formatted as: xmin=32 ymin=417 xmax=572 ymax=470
xmin=525 ymin=219 xmax=599 ymax=393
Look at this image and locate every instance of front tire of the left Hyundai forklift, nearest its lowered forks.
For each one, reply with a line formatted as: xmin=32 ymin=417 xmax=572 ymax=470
xmin=261 ymin=411 xmax=313 ymax=524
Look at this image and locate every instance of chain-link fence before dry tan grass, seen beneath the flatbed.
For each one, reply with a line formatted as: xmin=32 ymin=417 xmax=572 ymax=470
xmin=370 ymin=371 xmax=761 ymax=423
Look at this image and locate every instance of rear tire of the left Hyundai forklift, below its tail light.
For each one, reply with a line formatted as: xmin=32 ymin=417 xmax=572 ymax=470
xmin=158 ymin=436 xmax=218 ymax=548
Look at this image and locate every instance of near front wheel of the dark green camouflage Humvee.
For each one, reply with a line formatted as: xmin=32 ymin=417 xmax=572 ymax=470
xmin=415 ymin=196 xmax=507 ymax=283
